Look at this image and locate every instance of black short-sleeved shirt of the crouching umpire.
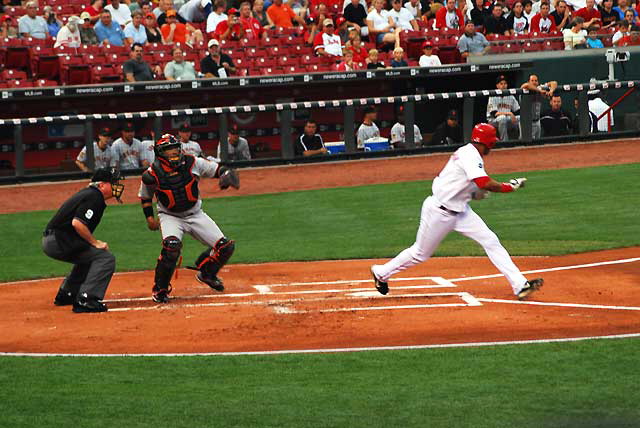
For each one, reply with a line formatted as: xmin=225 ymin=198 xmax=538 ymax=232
xmin=45 ymin=186 xmax=107 ymax=253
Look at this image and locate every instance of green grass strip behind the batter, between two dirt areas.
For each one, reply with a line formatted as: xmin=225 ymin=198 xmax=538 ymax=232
xmin=0 ymin=164 xmax=640 ymax=281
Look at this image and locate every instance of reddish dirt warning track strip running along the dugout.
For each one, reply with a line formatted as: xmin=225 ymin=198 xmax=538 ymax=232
xmin=0 ymin=139 xmax=640 ymax=214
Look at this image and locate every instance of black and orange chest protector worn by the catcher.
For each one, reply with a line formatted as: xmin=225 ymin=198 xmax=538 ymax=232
xmin=152 ymin=156 xmax=200 ymax=212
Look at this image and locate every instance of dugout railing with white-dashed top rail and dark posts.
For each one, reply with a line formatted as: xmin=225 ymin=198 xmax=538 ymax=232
xmin=0 ymin=80 xmax=640 ymax=184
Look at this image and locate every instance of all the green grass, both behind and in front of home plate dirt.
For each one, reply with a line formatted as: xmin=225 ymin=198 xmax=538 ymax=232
xmin=0 ymin=164 xmax=640 ymax=428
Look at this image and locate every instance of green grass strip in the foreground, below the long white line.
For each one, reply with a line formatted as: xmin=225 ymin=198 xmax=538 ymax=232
xmin=0 ymin=340 xmax=640 ymax=427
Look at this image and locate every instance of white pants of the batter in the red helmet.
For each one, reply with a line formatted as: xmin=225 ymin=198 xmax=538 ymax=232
xmin=372 ymin=196 xmax=527 ymax=294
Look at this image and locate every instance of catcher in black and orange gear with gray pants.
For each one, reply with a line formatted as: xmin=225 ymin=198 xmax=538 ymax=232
xmin=138 ymin=134 xmax=240 ymax=303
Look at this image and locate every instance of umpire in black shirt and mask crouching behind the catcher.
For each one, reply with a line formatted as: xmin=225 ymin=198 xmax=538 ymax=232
xmin=42 ymin=168 xmax=124 ymax=313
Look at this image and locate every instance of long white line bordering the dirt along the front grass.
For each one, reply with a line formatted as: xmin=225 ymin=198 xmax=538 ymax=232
xmin=5 ymin=333 xmax=640 ymax=358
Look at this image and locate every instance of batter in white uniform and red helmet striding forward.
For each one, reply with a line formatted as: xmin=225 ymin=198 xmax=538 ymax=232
xmin=371 ymin=123 xmax=544 ymax=299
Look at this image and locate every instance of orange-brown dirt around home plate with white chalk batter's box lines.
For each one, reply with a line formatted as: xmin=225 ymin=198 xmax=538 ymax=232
xmin=0 ymin=248 xmax=640 ymax=354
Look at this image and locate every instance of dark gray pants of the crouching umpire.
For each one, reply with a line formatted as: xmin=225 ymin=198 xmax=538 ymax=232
xmin=42 ymin=235 xmax=116 ymax=300
